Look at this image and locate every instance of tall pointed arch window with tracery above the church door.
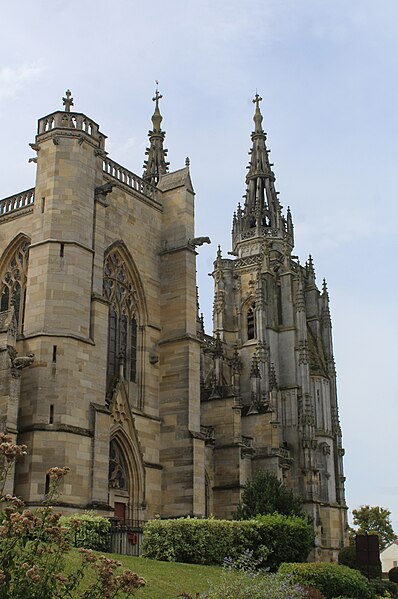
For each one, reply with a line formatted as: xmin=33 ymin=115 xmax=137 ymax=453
xmin=104 ymin=251 xmax=137 ymax=383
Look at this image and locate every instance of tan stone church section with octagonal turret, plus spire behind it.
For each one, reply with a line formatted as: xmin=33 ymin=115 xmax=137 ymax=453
xmin=0 ymin=90 xmax=204 ymax=520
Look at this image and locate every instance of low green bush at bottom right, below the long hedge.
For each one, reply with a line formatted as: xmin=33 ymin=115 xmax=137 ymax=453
xmin=279 ymin=562 xmax=374 ymax=599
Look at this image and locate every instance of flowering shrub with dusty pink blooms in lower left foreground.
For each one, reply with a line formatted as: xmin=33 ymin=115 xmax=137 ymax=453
xmin=0 ymin=433 xmax=145 ymax=599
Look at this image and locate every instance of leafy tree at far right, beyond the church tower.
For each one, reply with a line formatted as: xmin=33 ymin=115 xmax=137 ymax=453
xmin=352 ymin=505 xmax=397 ymax=550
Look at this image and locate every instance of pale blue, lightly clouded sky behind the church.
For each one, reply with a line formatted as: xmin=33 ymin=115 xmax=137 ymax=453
xmin=0 ymin=0 xmax=398 ymax=533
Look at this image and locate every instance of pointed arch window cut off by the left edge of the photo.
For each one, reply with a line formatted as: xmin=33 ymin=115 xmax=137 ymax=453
xmin=0 ymin=239 xmax=29 ymax=333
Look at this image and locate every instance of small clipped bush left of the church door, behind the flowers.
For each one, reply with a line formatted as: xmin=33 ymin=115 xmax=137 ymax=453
xmin=60 ymin=514 xmax=111 ymax=551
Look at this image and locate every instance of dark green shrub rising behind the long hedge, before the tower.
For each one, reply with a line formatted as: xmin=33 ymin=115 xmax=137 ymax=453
xmin=236 ymin=472 xmax=304 ymax=520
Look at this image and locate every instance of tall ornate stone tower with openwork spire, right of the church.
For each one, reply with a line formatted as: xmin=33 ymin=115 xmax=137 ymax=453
xmin=202 ymin=94 xmax=346 ymax=558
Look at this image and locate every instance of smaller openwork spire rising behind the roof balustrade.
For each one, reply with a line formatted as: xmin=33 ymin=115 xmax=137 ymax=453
xmin=142 ymin=82 xmax=170 ymax=185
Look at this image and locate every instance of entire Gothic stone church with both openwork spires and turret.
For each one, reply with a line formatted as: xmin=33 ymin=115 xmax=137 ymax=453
xmin=0 ymin=91 xmax=347 ymax=559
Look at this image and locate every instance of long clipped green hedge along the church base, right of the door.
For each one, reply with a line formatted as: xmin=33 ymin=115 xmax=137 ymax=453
xmin=142 ymin=514 xmax=314 ymax=570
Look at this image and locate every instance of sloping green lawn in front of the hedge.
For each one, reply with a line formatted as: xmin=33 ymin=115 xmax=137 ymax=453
xmin=66 ymin=550 xmax=223 ymax=599
